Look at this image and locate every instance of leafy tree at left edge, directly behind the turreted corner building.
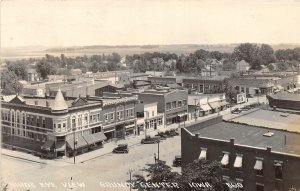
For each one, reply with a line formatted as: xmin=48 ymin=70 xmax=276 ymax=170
xmin=1 ymin=71 xmax=22 ymax=95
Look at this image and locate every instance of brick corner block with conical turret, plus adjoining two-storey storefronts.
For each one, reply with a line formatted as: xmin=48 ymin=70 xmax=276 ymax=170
xmin=1 ymin=89 xmax=136 ymax=157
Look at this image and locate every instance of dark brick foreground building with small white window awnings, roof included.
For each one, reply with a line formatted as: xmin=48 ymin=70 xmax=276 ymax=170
xmin=181 ymin=116 xmax=300 ymax=191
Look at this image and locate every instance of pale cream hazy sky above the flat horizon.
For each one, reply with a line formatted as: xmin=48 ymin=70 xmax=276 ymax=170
xmin=1 ymin=0 xmax=300 ymax=47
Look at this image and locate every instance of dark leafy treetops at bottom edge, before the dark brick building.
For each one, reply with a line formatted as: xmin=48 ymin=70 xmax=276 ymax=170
xmin=133 ymin=160 xmax=223 ymax=191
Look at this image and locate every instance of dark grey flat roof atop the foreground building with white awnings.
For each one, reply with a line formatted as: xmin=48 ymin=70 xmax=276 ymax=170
xmin=187 ymin=121 xmax=300 ymax=155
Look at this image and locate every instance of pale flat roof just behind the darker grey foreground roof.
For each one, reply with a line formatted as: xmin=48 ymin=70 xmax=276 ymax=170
xmin=228 ymin=110 xmax=300 ymax=133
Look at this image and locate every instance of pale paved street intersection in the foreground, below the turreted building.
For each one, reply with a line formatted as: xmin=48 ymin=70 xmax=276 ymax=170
xmin=1 ymin=136 xmax=180 ymax=191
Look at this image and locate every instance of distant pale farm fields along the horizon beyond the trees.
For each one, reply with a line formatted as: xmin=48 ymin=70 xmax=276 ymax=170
xmin=1 ymin=44 xmax=300 ymax=60
